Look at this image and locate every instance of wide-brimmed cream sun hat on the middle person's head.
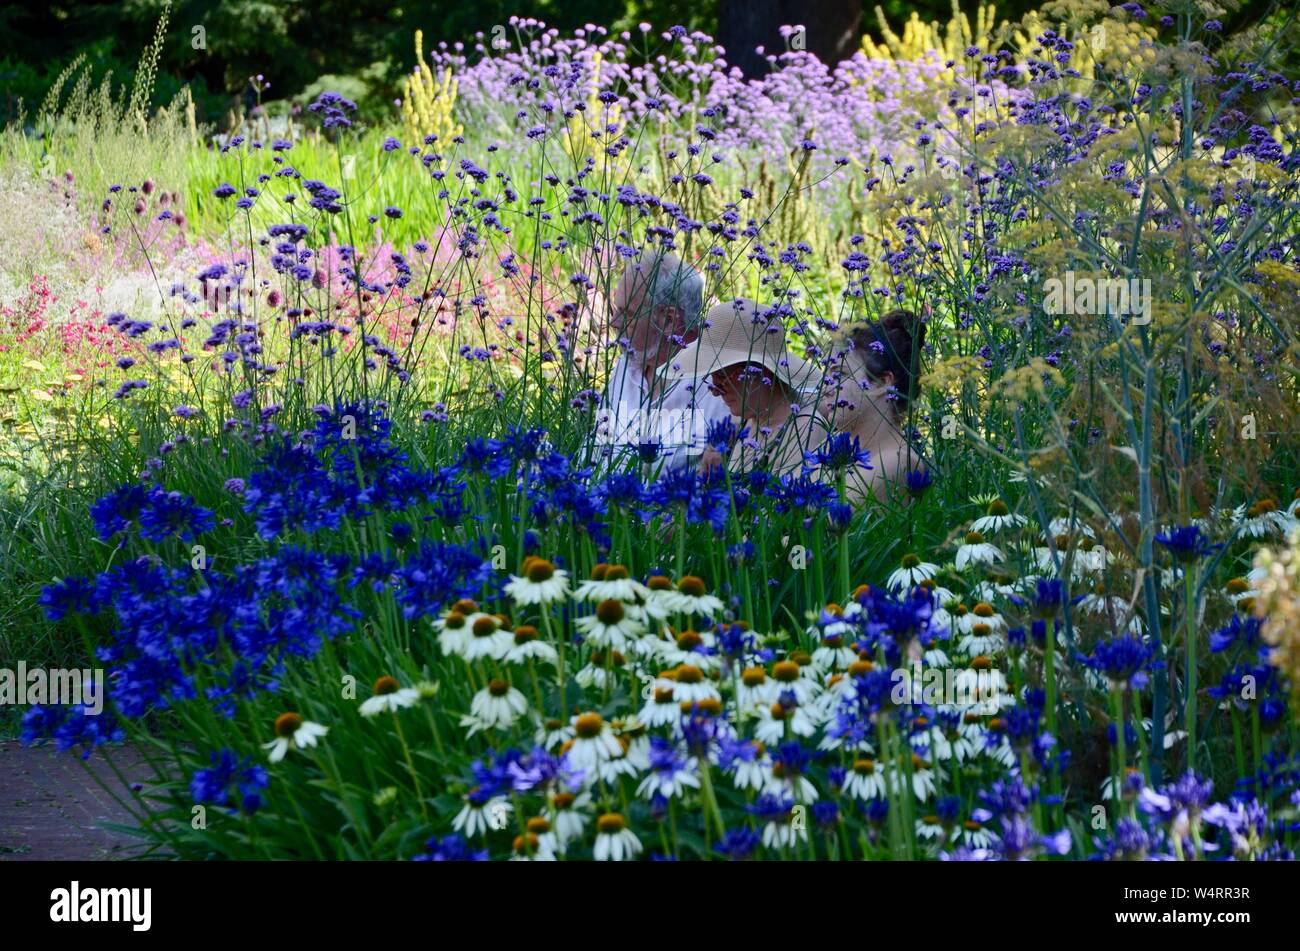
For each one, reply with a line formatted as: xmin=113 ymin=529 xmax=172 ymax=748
xmin=663 ymin=298 xmax=814 ymax=390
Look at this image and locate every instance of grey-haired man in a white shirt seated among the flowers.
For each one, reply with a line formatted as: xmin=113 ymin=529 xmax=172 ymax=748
xmin=597 ymin=251 xmax=731 ymax=472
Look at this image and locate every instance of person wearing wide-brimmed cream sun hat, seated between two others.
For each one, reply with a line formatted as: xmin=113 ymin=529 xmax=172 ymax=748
xmin=663 ymin=298 xmax=831 ymax=476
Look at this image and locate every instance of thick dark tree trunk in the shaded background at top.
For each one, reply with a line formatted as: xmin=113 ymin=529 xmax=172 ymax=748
xmin=718 ymin=0 xmax=862 ymax=78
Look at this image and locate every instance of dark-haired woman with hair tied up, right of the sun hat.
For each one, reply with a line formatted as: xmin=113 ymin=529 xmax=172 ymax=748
xmin=820 ymin=309 xmax=926 ymax=503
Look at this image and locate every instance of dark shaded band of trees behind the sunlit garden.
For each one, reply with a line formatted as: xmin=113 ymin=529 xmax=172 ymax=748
xmin=0 ymin=0 xmax=1269 ymax=121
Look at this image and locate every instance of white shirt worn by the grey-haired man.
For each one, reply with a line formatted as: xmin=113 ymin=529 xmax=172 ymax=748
xmin=595 ymin=352 xmax=732 ymax=469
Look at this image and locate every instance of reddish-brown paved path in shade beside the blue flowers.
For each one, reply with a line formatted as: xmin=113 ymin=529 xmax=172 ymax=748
xmin=0 ymin=741 xmax=152 ymax=861
